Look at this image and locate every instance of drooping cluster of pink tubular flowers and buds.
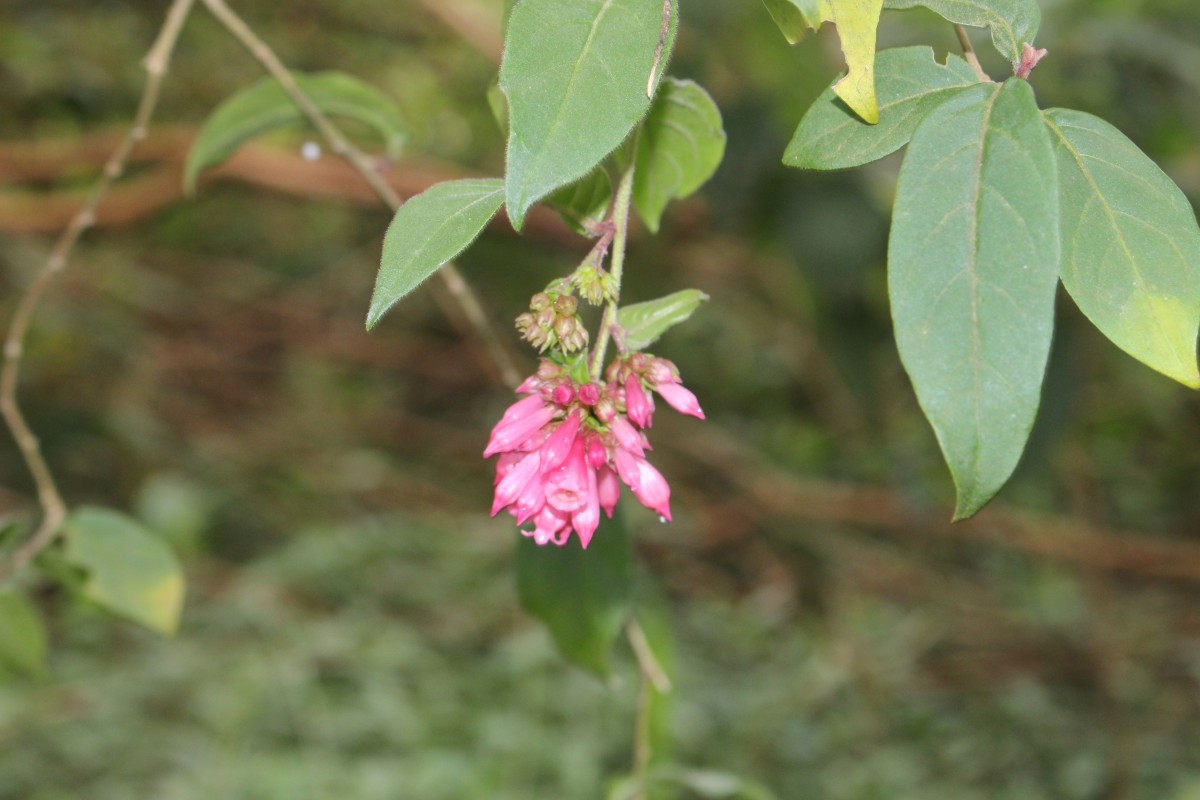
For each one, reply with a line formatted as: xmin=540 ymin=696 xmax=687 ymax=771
xmin=484 ymin=353 xmax=704 ymax=547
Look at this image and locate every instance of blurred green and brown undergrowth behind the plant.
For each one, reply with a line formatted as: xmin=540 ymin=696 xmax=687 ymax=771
xmin=0 ymin=0 xmax=1200 ymax=800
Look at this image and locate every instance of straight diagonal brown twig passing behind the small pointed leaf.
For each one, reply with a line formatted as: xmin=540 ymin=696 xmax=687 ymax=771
xmin=200 ymin=0 xmax=521 ymax=387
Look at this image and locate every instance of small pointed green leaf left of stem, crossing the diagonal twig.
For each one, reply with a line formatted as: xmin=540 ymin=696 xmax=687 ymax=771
xmin=367 ymin=178 xmax=504 ymax=330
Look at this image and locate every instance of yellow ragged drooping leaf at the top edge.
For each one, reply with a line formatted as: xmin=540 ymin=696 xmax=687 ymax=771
xmin=763 ymin=0 xmax=883 ymax=125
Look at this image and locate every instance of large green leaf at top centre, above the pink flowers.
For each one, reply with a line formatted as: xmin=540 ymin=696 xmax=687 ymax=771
xmin=500 ymin=0 xmax=676 ymax=229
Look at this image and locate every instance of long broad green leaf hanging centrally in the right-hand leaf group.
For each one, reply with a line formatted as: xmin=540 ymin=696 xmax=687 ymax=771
xmin=888 ymin=78 xmax=1058 ymax=519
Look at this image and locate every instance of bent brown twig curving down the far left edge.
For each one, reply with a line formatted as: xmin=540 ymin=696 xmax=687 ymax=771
xmin=0 ymin=0 xmax=193 ymax=581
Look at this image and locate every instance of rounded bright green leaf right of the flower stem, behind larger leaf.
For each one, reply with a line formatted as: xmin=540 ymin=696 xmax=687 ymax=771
xmin=634 ymin=78 xmax=725 ymax=233
